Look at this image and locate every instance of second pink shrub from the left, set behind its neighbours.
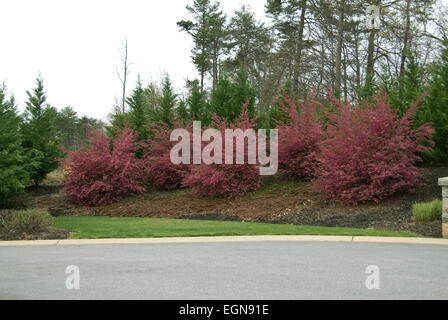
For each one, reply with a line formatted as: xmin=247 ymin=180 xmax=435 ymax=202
xmin=143 ymin=122 xmax=192 ymax=190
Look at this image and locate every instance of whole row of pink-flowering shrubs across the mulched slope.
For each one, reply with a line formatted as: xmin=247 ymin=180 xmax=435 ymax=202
xmin=62 ymin=95 xmax=433 ymax=205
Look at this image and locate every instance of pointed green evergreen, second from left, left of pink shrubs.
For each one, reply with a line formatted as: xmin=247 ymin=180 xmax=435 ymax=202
xmin=22 ymin=77 xmax=61 ymax=185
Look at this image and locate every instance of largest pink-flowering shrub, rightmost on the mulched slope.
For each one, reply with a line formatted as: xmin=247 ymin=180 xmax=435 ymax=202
xmin=314 ymin=95 xmax=433 ymax=204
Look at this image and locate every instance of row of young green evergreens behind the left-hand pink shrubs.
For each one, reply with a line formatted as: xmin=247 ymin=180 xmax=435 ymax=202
xmin=108 ymin=72 xmax=257 ymax=140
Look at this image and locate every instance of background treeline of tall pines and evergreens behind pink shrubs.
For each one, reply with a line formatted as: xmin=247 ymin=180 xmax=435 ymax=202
xmin=110 ymin=0 xmax=448 ymax=163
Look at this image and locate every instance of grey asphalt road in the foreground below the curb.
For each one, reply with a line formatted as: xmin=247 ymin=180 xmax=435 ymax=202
xmin=0 ymin=242 xmax=448 ymax=300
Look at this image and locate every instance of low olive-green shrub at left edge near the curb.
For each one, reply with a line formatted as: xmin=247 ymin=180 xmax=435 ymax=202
xmin=0 ymin=209 xmax=53 ymax=234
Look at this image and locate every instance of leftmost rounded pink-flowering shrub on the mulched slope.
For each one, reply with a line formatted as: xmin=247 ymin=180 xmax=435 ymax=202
xmin=61 ymin=129 xmax=147 ymax=205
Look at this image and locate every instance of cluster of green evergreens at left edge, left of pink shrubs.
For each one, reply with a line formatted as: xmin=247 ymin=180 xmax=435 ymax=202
xmin=0 ymin=77 xmax=101 ymax=205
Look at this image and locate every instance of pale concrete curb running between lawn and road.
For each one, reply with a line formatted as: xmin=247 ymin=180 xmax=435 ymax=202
xmin=0 ymin=236 xmax=448 ymax=247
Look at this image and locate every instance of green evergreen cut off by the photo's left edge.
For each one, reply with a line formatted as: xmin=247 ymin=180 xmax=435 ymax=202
xmin=0 ymin=84 xmax=29 ymax=205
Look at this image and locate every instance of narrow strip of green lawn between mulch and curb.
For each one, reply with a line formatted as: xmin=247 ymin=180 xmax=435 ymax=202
xmin=54 ymin=217 xmax=418 ymax=239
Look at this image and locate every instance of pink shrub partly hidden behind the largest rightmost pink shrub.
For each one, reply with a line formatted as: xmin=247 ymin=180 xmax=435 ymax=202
xmin=276 ymin=93 xmax=323 ymax=180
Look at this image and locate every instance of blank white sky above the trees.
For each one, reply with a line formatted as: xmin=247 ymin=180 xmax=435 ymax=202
xmin=0 ymin=0 xmax=265 ymax=120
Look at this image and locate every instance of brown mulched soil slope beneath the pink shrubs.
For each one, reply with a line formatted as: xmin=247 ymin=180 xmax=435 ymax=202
xmin=26 ymin=168 xmax=448 ymax=237
